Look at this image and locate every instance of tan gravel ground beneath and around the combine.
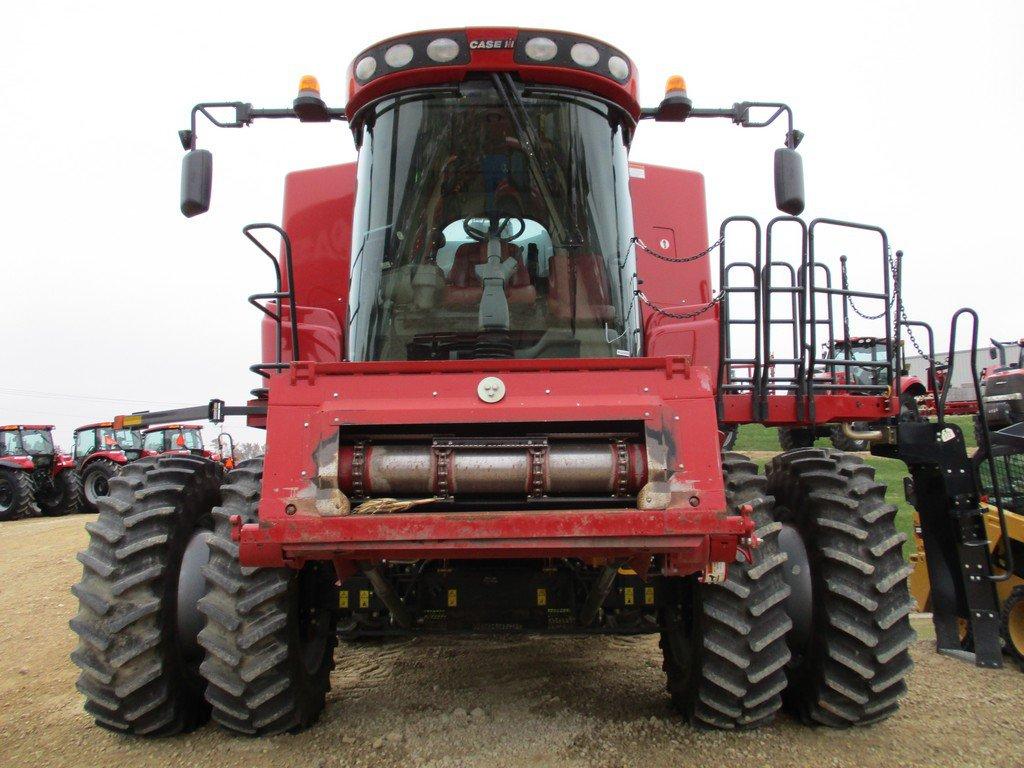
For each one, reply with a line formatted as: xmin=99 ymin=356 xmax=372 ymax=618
xmin=0 ymin=515 xmax=1024 ymax=768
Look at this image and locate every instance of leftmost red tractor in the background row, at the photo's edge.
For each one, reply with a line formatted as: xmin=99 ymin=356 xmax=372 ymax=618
xmin=0 ymin=424 xmax=82 ymax=520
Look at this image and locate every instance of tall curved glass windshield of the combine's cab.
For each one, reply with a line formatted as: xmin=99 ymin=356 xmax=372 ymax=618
xmin=347 ymin=76 xmax=640 ymax=360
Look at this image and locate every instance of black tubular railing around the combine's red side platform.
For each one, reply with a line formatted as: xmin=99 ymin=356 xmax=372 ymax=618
xmin=718 ymin=216 xmax=901 ymax=423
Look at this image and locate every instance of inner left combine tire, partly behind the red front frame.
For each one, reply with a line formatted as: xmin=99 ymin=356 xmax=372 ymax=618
xmin=199 ymin=459 xmax=337 ymax=736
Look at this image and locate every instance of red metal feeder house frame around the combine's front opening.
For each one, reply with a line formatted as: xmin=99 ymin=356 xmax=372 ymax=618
xmin=242 ymin=358 xmax=733 ymax=568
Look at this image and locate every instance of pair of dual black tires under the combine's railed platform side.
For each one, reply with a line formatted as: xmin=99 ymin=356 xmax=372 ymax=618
xmin=662 ymin=449 xmax=914 ymax=729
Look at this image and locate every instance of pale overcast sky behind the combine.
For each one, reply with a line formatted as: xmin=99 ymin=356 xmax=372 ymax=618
xmin=0 ymin=0 xmax=1024 ymax=447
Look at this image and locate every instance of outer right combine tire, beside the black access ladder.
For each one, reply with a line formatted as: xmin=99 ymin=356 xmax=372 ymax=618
xmin=767 ymin=449 xmax=914 ymax=728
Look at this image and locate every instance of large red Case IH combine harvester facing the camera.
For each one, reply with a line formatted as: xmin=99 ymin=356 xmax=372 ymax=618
xmin=72 ymin=28 xmax=1015 ymax=735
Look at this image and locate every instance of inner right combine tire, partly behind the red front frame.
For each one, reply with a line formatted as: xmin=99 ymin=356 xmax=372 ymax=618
xmin=660 ymin=454 xmax=792 ymax=729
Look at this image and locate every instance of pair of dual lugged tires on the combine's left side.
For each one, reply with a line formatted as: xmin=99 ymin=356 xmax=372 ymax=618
xmin=71 ymin=457 xmax=334 ymax=736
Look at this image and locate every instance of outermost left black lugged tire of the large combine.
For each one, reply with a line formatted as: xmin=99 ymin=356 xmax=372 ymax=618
xmin=71 ymin=456 xmax=222 ymax=736
